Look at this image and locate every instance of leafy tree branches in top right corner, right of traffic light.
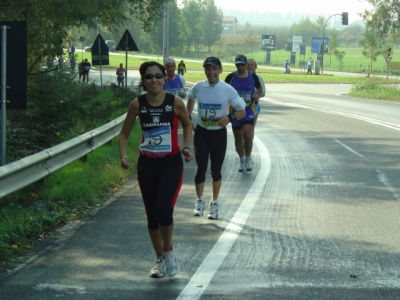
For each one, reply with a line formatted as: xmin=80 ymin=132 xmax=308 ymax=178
xmin=362 ymin=0 xmax=400 ymax=41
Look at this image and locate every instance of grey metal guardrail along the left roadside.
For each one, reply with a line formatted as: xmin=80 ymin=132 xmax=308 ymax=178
xmin=0 ymin=114 xmax=126 ymax=198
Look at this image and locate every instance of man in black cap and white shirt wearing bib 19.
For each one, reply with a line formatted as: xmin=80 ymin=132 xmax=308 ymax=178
xmin=186 ymin=57 xmax=246 ymax=220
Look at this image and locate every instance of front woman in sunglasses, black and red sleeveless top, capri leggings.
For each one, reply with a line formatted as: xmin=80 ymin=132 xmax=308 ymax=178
xmin=118 ymin=61 xmax=193 ymax=278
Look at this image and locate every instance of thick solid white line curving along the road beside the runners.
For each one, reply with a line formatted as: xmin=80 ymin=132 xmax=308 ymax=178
xmin=177 ymin=136 xmax=271 ymax=300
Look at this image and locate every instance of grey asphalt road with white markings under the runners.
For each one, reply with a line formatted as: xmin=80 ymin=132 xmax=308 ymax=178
xmin=0 ymin=84 xmax=400 ymax=300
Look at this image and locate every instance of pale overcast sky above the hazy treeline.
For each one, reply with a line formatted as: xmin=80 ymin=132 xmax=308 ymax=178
xmin=178 ymin=0 xmax=371 ymax=22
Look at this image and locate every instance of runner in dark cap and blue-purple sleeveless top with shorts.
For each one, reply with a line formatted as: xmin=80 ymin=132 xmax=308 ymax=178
xmin=225 ymin=54 xmax=262 ymax=172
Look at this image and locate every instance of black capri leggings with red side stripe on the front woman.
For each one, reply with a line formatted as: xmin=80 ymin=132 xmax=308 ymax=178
xmin=137 ymin=153 xmax=183 ymax=230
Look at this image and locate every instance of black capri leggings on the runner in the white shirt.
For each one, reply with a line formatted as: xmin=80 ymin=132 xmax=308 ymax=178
xmin=194 ymin=126 xmax=228 ymax=184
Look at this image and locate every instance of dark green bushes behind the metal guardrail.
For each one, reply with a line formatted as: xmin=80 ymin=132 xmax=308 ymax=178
xmin=7 ymin=71 xmax=137 ymax=162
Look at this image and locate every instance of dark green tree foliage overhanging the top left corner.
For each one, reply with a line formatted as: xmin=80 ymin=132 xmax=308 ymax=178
xmin=0 ymin=0 xmax=163 ymax=75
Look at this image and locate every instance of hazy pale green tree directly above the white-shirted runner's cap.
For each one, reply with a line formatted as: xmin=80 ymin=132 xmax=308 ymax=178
xmin=201 ymin=0 xmax=222 ymax=53
